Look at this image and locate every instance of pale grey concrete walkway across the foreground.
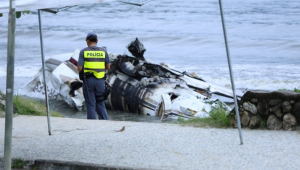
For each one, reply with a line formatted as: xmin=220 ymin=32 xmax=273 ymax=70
xmin=0 ymin=116 xmax=300 ymax=170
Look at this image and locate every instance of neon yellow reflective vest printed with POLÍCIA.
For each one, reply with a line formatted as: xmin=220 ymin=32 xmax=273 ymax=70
xmin=83 ymin=51 xmax=105 ymax=79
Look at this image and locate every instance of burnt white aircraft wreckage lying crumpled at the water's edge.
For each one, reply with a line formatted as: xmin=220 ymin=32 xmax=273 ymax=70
xmin=18 ymin=39 xmax=238 ymax=119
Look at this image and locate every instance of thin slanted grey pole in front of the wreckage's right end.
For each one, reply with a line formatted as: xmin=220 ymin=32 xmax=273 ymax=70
xmin=219 ymin=0 xmax=243 ymax=145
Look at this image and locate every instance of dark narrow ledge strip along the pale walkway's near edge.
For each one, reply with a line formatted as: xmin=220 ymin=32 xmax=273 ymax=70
xmin=0 ymin=157 xmax=150 ymax=170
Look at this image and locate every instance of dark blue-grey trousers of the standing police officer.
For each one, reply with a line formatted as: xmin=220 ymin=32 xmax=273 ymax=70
xmin=82 ymin=76 xmax=108 ymax=120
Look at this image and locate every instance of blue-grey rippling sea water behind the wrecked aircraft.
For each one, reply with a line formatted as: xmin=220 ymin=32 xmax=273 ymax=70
xmin=0 ymin=0 xmax=300 ymax=119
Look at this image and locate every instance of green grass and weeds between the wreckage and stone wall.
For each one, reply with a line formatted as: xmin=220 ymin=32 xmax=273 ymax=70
xmin=176 ymin=108 xmax=231 ymax=128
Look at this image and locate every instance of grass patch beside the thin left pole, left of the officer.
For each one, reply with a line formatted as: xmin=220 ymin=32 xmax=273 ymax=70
xmin=14 ymin=96 xmax=63 ymax=117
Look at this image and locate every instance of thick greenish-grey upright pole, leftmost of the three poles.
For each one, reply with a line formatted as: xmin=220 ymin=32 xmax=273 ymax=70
xmin=4 ymin=0 xmax=16 ymax=170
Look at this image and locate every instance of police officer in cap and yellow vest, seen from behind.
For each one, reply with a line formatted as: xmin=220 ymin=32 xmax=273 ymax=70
xmin=77 ymin=33 xmax=110 ymax=120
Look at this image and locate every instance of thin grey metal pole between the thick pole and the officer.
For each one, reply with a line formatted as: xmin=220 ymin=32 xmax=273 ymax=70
xmin=38 ymin=9 xmax=51 ymax=135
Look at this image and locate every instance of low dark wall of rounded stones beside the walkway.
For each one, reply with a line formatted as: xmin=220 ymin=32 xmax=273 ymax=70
xmin=231 ymin=90 xmax=300 ymax=130
